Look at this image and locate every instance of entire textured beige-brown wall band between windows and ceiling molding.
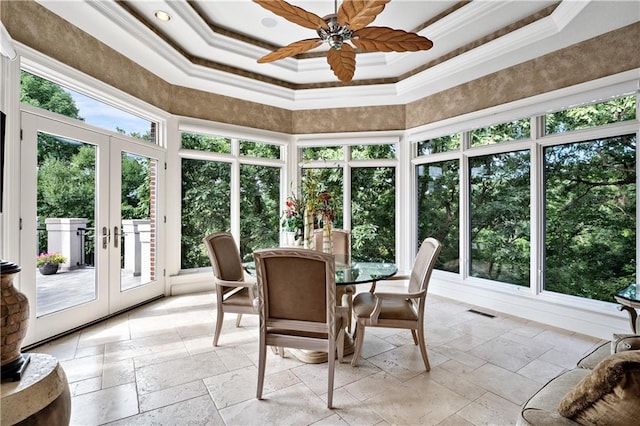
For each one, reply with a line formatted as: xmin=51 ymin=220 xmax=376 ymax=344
xmin=0 ymin=0 xmax=640 ymax=134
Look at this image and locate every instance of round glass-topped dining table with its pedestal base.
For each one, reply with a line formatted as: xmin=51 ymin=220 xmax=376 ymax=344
xmin=244 ymin=254 xmax=398 ymax=364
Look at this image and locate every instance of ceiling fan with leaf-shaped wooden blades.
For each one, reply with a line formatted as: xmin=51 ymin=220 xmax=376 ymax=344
xmin=253 ymin=0 xmax=433 ymax=83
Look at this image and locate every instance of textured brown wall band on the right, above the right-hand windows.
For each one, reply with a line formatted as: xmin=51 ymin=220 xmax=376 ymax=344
xmin=406 ymin=23 xmax=640 ymax=129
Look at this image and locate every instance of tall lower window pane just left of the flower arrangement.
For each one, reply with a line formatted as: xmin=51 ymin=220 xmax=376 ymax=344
xmin=240 ymin=164 xmax=280 ymax=262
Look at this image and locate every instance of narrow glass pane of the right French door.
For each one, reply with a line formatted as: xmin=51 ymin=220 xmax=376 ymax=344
xmin=119 ymin=152 xmax=158 ymax=291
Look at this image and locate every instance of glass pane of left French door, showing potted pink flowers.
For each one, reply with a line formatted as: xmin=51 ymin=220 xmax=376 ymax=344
xmin=34 ymin=132 xmax=97 ymax=317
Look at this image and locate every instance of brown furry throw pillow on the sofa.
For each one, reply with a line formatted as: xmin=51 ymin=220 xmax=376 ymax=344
xmin=558 ymin=351 xmax=640 ymax=425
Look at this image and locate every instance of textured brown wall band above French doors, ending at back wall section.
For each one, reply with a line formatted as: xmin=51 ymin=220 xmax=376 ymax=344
xmin=0 ymin=1 xmax=291 ymax=133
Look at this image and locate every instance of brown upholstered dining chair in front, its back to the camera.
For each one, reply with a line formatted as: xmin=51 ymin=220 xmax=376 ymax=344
xmin=254 ymin=248 xmax=347 ymax=408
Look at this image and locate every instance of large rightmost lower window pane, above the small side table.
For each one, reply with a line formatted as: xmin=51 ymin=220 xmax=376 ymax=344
xmin=544 ymin=135 xmax=636 ymax=302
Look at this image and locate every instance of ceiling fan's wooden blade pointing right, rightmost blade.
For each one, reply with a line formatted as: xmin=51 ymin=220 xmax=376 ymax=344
xmin=351 ymin=27 xmax=433 ymax=52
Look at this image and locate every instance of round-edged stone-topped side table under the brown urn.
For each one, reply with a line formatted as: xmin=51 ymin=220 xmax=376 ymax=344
xmin=0 ymin=353 xmax=71 ymax=426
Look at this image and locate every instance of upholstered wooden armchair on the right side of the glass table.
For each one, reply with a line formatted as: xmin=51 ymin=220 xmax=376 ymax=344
xmin=351 ymin=238 xmax=442 ymax=371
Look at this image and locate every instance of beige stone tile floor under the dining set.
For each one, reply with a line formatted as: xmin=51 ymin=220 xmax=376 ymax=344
xmin=32 ymin=285 xmax=602 ymax=426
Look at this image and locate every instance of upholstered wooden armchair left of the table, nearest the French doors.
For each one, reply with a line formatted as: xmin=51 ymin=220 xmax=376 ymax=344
xmin=202 ymin=232 xmax=258 ymax=346
